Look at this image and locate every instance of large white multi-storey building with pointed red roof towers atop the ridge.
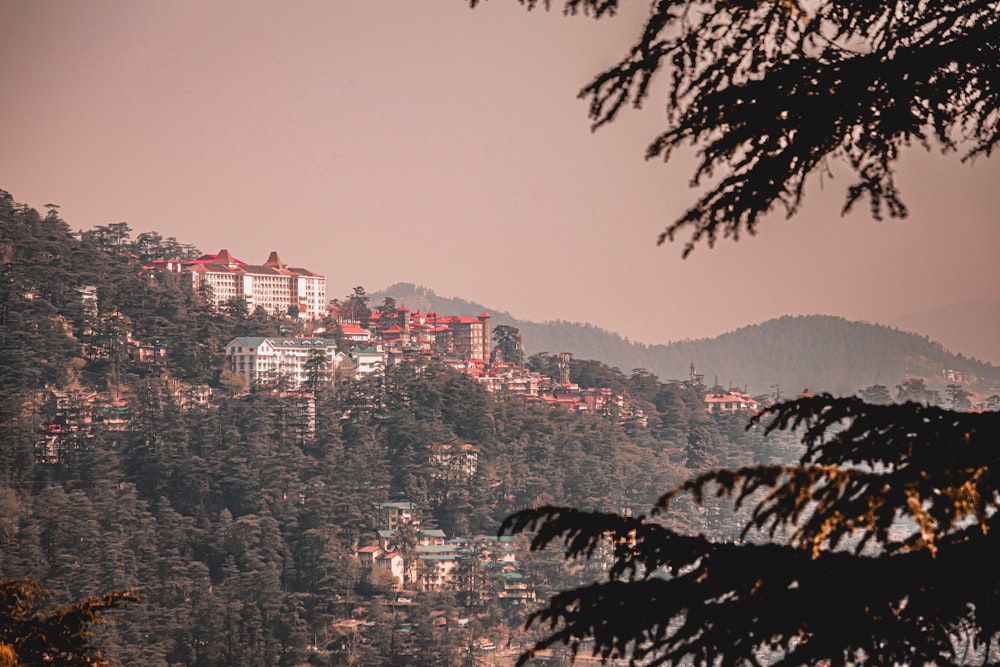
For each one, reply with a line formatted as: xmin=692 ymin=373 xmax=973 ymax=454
xmin=183 ymin=249 xmax=326 ymax=320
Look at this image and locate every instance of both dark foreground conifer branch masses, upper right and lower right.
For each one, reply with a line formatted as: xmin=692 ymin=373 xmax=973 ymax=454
xmin=478 ymin=0 xmax=1000 ymax=667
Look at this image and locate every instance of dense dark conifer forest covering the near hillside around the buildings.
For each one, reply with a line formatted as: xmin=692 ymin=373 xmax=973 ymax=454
xmin=0 ymin=192 xmax=980 ymax=666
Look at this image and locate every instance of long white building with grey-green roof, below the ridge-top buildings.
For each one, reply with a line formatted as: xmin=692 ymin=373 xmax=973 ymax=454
xmin=226 ymin=336 xmax=341 ymax=389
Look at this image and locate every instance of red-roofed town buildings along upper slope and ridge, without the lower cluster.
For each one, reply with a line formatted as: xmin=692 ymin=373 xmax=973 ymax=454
xmin=36 ymin=249 xmax=992 ymax=470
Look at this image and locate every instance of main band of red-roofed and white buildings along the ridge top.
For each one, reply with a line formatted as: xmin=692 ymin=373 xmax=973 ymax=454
xmin=139 ymin=249 xmax=645 ymax=421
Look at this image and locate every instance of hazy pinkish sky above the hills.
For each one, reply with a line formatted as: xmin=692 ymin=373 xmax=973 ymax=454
xmin=0 ymin=0 xmax=1000 ymax=350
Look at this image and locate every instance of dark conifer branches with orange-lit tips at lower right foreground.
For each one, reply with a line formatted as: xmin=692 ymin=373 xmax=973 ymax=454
xmin=501 ymin=396 xmax=1000 ymax=665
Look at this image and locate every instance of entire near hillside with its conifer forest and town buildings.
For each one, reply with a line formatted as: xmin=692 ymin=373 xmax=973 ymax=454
xmin=0 ymin=196 xmax=1000 ymax=667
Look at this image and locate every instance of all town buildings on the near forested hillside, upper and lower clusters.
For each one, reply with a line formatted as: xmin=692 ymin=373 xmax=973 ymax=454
xmin=35 ymin=249 xmax=645 ymax=622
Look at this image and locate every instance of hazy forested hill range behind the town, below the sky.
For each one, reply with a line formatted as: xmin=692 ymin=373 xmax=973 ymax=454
xmin=371 ymin=283 xmax=1000 ymax=394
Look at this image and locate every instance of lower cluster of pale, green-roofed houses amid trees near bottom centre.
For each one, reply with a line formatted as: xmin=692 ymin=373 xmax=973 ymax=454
xmin=356 ymin=500 xmax=535 ymax=604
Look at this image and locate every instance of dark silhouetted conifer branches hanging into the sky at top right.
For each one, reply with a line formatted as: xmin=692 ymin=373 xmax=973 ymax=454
xmin=470 ymin=0 xmax=1000 ymax=256
